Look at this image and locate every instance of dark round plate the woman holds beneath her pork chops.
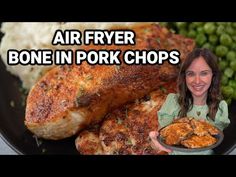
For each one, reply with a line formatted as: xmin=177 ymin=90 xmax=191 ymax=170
xmin=158 ymin=130 xmax=224 ymax=152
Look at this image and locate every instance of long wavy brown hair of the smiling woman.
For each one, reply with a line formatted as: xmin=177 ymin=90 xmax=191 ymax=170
xmin=178 ymin=48 xmax=222 ymax=120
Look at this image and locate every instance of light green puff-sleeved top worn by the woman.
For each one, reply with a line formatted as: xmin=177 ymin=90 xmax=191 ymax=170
xmin=158 ymin=93 xmax=230 ymax=155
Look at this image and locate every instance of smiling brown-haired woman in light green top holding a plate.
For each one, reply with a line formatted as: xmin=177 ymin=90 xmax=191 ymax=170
xmin=149 ymin=48 xmax=230 ymax=154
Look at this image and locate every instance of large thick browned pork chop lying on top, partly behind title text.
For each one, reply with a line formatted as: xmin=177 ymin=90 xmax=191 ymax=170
xmin=25 ymin=25 xmax=195 ymax=140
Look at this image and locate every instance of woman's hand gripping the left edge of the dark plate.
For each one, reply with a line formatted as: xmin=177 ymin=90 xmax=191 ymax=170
xmin=149 ymin=131 xmax=172 ymax=153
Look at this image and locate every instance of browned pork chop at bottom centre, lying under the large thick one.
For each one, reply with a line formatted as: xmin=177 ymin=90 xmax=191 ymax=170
xmin=76 ymin=82 xmax=176 ymax=155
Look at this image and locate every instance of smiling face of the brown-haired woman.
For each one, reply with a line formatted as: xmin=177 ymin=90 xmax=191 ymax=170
xmin=185 ymin=57 xmax=212 ymax=98
